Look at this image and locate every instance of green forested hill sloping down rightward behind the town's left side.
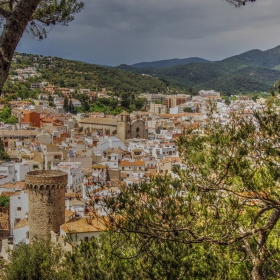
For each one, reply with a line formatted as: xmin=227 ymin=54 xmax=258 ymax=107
xmin=10 ymin=53 xmax=174 ymax=93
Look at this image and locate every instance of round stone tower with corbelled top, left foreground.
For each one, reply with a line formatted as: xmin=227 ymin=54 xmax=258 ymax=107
xmin=25 ymin=170 xmax=68 ymax=240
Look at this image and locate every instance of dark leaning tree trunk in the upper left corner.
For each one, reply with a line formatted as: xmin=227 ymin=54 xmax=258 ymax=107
xmin=0 ymin=0 xmax=41 ymax=94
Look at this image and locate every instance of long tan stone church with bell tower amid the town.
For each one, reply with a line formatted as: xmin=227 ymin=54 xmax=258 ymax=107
xmin=79 ymin=111 xmax=148 ymax=141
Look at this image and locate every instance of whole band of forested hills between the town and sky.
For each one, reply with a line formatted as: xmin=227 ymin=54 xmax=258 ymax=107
xmin=11 ymin=46 xmax=280 ymax=94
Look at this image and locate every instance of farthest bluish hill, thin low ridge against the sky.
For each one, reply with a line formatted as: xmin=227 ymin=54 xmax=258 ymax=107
xmin=130 ymin=57 xmax=209 ymax=69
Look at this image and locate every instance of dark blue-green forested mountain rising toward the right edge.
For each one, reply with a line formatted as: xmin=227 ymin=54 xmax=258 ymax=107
xmin=119 ymin=46 xmax=280 ymax=94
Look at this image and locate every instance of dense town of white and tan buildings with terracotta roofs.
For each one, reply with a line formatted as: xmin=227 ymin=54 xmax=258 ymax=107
xmin=0 ymin=64 xmax=266 ymax=258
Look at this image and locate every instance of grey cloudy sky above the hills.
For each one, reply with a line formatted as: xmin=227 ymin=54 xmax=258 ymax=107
xmin=17 ymin=0 xmax=280 ymax=66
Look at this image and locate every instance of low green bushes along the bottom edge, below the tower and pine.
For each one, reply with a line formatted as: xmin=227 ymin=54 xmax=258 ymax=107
xmin=0 ymin=232 xmax=250 ymax=280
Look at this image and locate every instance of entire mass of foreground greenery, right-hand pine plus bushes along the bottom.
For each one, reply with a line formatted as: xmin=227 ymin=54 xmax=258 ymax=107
xmin=3 ymin=96 xmax=280 ymax=280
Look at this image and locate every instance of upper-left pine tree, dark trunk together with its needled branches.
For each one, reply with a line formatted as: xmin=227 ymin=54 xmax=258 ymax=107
xmin=0 ymin=0 xmax=83 ymax=94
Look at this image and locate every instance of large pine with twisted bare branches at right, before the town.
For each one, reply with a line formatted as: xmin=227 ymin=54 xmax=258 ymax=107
xmin=101 ymin=100 xmax=280 ymax=279
